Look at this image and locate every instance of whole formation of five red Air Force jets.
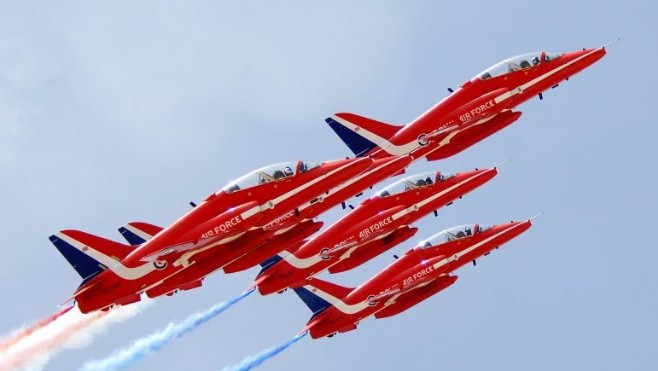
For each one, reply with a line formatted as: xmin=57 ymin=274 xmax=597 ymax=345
xmin=50 ymin=47 xmax=606 ymax=338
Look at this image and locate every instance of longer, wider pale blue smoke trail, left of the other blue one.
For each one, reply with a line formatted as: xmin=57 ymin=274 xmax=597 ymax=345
xmin=80 ymin=289 xmax=254 ymax=371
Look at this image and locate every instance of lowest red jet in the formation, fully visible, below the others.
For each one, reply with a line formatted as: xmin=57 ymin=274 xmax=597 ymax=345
xmin=294 ymin=220 xmax=531 ymax=339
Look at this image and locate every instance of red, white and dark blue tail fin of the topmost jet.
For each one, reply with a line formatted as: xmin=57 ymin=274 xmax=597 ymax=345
xmin=325 ymin=113 xmax=402 ymax=157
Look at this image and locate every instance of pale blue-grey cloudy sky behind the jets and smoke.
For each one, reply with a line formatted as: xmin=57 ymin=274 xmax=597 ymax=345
xmin=0 ymin=1 xmax=658 ymax=370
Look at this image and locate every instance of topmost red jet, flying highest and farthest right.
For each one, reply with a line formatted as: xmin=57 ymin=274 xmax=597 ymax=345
xmin=326 ymin=46 xmax=606 ymax=161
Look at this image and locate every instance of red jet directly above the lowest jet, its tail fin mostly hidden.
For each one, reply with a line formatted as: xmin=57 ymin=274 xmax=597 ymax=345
xmin=253 ymin=167 xmax=497 ymax=295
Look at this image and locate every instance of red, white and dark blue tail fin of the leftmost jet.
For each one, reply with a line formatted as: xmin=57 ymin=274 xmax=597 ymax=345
xmin=50 ymin=230 xmax=133 ymax=281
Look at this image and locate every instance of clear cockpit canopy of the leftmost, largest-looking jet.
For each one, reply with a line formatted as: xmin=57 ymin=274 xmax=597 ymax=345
xmin=222 ymin=161 xmax=322 ymax=193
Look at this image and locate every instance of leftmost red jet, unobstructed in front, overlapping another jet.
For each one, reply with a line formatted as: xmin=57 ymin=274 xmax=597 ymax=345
xmin=50 ymin=158 xmax=373 ymax=313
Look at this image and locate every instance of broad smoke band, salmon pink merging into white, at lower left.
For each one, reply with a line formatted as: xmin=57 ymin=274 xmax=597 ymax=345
xmin=0 ymin=301 xmax=151 ymax=370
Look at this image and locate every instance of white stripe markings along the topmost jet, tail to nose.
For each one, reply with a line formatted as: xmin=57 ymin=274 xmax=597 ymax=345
xmin=344 ymin=49 xmax=599 ymax=156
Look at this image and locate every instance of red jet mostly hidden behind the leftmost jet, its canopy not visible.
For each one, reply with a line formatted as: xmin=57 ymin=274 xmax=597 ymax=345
xmin=113 ymin=156 xmax=411 ymax=298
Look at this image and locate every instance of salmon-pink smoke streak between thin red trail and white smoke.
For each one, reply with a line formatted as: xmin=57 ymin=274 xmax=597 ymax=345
xmin=0 ymin=311 xmax=108 ymax=370
